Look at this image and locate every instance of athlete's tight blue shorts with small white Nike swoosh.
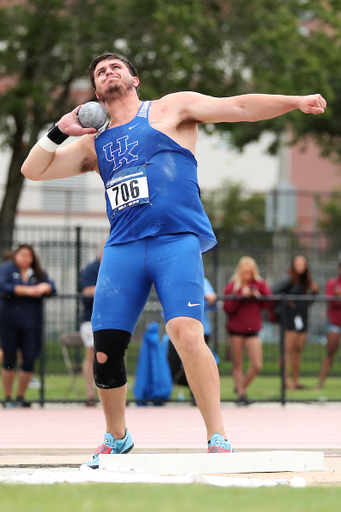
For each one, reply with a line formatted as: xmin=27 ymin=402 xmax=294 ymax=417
xmin=91 ymin=233 xmax=204 ymax=334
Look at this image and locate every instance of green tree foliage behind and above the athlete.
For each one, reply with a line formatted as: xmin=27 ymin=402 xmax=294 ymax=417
xmin=0 ymin=0 xmax=341 ymax=248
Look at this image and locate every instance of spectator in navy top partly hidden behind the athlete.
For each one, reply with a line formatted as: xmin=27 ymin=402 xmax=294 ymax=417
xmin=80 ymin=245 xmax=104 ymax=407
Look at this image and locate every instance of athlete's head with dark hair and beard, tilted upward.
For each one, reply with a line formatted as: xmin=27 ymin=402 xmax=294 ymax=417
xmin=94 ymin=60 xmax=138 ymax=102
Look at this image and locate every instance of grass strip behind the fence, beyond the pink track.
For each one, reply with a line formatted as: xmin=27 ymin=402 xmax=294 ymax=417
xmin=0 ymin=336 xmax=341 ymax=401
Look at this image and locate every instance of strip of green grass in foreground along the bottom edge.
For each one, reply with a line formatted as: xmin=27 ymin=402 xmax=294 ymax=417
xmin=0 ymin=484 xmax=341 ymax=512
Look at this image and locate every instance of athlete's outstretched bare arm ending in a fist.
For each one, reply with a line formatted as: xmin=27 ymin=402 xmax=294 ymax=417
xmin=174 ymin=92 xmax=327 ymax=123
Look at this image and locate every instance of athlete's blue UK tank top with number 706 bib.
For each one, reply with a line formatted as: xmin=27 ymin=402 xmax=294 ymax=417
xmin=95 ymin=101 xmax=217 ymax=253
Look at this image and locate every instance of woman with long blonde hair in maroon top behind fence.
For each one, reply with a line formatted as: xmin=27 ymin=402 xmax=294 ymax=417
xmin=224 ymin=256 xmax=272 ymax=405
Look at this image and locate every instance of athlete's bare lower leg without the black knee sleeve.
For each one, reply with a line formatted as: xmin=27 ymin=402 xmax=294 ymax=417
xmin=166 ymin=317 xmax=226 ymax=440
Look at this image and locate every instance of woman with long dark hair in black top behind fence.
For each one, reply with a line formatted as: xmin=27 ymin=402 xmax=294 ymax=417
xmin=272 ymin=255 xmax=318 ymax=389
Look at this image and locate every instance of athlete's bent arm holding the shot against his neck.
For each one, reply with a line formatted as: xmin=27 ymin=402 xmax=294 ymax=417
xmin=21 ymin=106 xmax=97 ymax=181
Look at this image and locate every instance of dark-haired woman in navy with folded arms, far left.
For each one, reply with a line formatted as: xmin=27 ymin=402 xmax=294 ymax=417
xmin=0 ymin=244 xmax=56 ymax=407
